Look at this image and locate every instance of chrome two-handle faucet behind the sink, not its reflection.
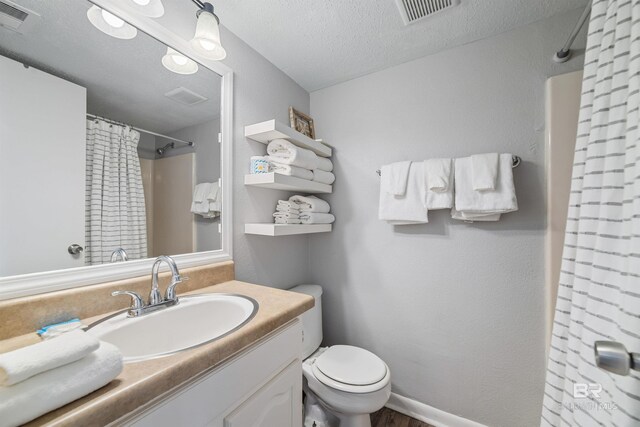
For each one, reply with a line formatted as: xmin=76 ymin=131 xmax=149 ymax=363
xmin=111 ymin=255 xmax=189 ymax=317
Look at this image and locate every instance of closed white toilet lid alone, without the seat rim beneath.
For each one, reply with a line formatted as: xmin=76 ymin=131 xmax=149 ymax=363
xmin=315 ymin=345 xmax=387 ymax=386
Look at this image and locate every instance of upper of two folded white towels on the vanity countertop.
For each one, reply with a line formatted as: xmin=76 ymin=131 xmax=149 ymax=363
xmin=0 ymin=330 xmax=100 ymax=386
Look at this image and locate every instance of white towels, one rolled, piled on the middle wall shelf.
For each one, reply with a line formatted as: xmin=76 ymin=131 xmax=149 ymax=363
xmin=267 ymin=139 xmax=336 ymax=185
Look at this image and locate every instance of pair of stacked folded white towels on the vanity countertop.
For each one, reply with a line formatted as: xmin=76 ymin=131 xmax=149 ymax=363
xmin=0 ymin=330 xmax=122 ymax=426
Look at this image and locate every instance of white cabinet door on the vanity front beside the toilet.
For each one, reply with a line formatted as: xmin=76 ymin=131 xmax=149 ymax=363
xmin=224 ymin=360 xmax=302 ymax=427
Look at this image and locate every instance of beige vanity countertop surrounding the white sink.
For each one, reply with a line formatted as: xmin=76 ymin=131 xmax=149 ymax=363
xmin=0 ymin=280 xmax=314 ymax=426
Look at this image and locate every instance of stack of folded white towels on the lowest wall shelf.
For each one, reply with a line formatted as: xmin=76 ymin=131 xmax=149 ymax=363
xmin=273 ymin=196 xmax=336 ymax=224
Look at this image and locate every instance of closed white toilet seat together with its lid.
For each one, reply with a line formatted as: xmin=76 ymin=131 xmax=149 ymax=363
xmin=312 ymin=345 xmax=391 ymax=393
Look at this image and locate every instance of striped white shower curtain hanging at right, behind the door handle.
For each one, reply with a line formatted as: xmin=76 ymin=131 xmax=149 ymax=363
xmin=541 ymin=0 xmax=640 ymax=427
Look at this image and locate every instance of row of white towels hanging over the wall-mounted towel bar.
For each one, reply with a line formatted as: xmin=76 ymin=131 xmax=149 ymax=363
xmin=379 ymin=153 xmax=518 ymax=225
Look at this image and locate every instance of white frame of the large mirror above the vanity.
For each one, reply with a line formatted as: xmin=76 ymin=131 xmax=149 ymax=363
xmin=0 ymin=0 xmax=233 ymax=300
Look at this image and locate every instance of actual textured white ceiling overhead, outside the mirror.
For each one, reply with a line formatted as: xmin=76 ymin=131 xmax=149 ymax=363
xmin=215 ymin=0 xmax=588 ymax=91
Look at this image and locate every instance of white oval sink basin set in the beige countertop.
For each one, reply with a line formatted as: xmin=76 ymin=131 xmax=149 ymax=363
xmin=87 ymin=294 xmax=258 ymax=362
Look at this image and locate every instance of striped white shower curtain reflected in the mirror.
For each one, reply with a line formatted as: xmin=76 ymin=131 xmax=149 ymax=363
xmin=85 ymin=119 xmax=147 ymax=265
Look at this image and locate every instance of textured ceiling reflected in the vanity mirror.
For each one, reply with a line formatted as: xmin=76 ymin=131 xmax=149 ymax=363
xmin=0 ymin=0 xmax=220 ymax=133
